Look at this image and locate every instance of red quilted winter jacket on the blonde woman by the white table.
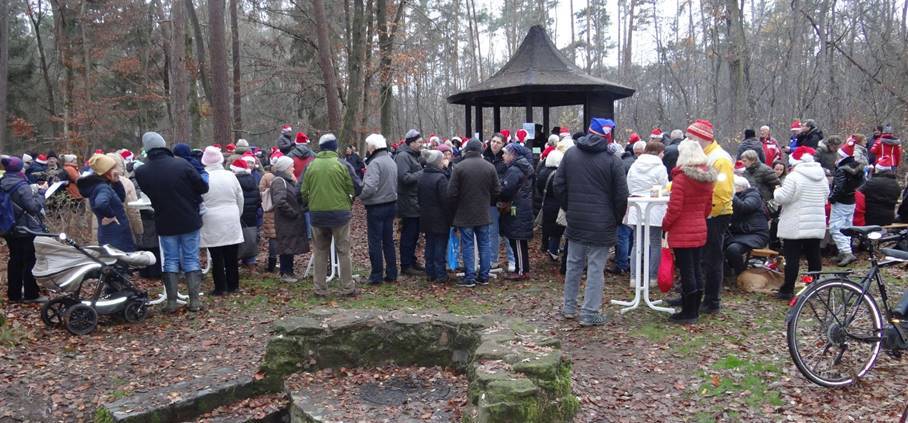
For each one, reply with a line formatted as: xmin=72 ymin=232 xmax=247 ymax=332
xmin=662 ymin=166 xmax=716 ymax=248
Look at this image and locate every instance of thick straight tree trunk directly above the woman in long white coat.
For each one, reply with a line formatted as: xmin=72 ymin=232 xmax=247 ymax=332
xmin=208 ymin=0 xmax=232 ymax=144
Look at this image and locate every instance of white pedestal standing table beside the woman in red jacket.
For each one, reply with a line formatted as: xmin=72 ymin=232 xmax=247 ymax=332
xmin=611 ymin=197 xmax=675 ymax=314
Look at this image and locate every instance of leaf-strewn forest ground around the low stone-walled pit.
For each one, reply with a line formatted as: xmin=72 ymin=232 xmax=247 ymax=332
xmin=0 ymin=204 xmax=908 ymax=422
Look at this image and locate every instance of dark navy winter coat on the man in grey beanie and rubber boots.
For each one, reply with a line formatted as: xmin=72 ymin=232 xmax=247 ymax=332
xmin=136 ymin=148 xmax=208 ymax=236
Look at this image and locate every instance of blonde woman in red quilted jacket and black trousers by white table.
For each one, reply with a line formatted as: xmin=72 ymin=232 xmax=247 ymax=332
xmin=662 ymin=140 xmax=722 ymax=323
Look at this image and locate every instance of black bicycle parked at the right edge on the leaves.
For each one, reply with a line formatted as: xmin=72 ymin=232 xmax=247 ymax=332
xmin=786 ymin=226 xmax=908 ymax=387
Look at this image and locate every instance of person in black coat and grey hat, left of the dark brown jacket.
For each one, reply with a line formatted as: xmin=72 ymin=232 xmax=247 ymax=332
xmin=418 ymin=150 xmax=451 ymax=284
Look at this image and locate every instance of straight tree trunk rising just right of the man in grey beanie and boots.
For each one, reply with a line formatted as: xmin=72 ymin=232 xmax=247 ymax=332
xmin=170 ymin=2 xmax=191 ymax=142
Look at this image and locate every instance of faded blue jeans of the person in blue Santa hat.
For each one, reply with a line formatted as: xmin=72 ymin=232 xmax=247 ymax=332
xmin=562 ymin=241 xmax=610 ymax=319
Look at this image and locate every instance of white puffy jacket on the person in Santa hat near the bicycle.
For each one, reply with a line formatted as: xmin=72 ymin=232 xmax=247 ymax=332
xmin=773 ymin=162 xmax=829 ymax=239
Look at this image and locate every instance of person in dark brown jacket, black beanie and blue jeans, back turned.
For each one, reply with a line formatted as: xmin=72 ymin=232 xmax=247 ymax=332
xmin=448 ymin=139 xmax=501 ymax=288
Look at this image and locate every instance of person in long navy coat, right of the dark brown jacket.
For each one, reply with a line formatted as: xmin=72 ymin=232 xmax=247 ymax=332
xmin=498 ymin=143 xmax=534 ymax=280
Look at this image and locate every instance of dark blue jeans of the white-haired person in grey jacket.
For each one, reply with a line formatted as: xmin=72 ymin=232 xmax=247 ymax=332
xmin=366 ymin=202 xmax=397 ymax=283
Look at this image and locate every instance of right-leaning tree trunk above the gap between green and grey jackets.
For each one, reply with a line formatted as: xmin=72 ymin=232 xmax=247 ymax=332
xmin=339 ymin=0 xmax=365 ymax=145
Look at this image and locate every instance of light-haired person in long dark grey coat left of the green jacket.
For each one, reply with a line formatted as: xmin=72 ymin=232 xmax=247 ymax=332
xmin=270 ymin=156 xmax=309 ymax=283
